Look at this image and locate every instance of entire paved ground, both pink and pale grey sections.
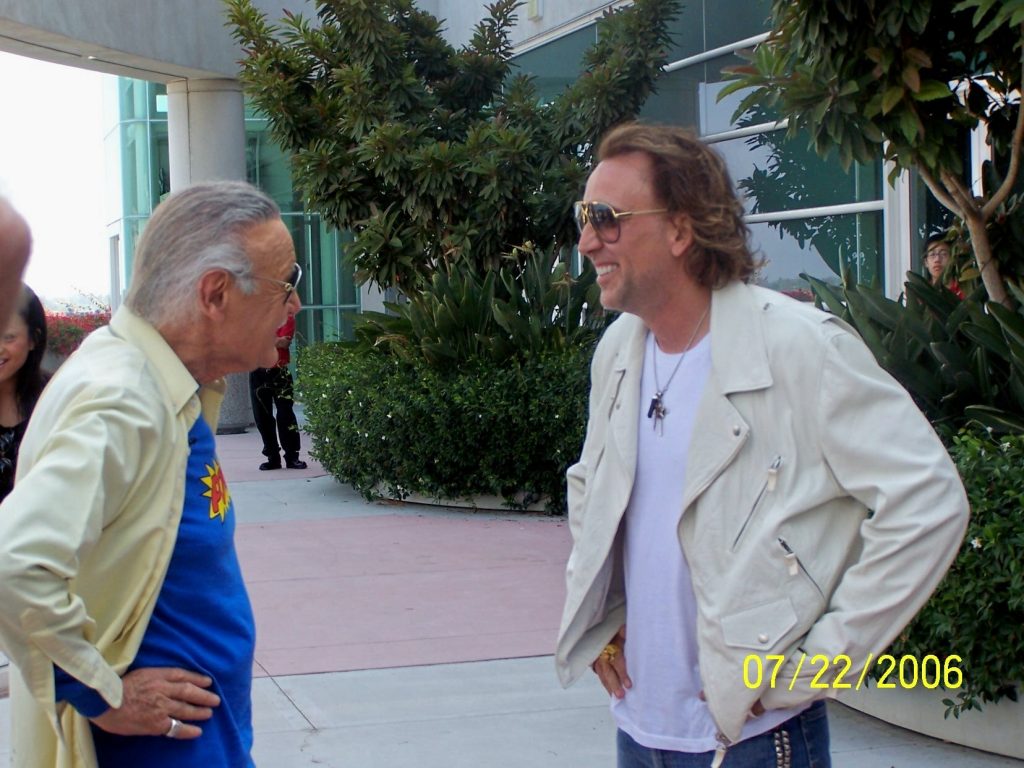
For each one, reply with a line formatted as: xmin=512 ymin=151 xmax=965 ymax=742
xmin=0 ymin=432 xmax=1024 ymax=768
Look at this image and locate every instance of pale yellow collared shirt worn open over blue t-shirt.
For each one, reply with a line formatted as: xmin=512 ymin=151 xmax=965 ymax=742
xmin=0 ymin=307 xmax=223 ymax=768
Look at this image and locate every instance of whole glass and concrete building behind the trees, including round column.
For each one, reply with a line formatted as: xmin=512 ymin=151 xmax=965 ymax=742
xmin=0 ymin=0 xmax=970 ymax=321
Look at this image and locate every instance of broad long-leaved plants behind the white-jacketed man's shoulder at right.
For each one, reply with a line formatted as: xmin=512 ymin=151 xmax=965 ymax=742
xmin=803 ymin=272 xmax=1024 ymax=434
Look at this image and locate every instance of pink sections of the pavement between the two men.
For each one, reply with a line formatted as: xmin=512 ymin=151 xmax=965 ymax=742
xmin=217 ymin=431 xmax=569 ymax=676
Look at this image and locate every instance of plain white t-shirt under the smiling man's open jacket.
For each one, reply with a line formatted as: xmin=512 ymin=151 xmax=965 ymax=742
xmin=611 ymin=333 xmax=803 ymax=753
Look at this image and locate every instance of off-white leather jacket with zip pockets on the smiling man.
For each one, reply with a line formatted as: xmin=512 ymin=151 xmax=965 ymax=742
xmin=555 ymin=283 xmax=968 ymax=746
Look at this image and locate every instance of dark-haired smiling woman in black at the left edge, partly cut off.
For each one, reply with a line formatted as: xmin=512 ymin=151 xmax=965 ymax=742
xmin=0 ymin=286 xmax=47 ymax=501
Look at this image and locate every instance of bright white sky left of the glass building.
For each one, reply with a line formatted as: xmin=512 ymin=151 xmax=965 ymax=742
xmin=0 ymin=52 xmax=116 ymax=308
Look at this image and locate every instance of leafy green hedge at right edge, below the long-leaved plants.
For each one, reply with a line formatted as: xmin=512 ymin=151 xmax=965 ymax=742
xmin=892 ymin=430 xmax=1024 ymax=717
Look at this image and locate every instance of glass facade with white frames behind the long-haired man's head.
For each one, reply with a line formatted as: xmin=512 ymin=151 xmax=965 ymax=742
xmin=431 ymin=0 xmax=966 ymax=297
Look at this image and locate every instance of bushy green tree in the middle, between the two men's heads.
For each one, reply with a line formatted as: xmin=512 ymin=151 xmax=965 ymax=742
xmin=225 ymin=0 xmax=679 ymax=292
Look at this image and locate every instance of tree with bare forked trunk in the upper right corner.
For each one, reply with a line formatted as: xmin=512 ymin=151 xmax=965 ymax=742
xmin=723 ymin=0 xmax=1024 ymax=304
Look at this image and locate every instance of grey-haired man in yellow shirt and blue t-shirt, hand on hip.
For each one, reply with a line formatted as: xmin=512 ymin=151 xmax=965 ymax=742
xmin=0 ymin=182 xmax=301 ymax=768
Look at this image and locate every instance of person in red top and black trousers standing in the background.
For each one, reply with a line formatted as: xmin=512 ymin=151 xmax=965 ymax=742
xmin=249 ymin=315 xmax=306 ymax=470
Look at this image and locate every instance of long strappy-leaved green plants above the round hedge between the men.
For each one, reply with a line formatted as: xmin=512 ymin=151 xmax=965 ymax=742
xmin=355 ymin=246 xmax=602 ymax=367
